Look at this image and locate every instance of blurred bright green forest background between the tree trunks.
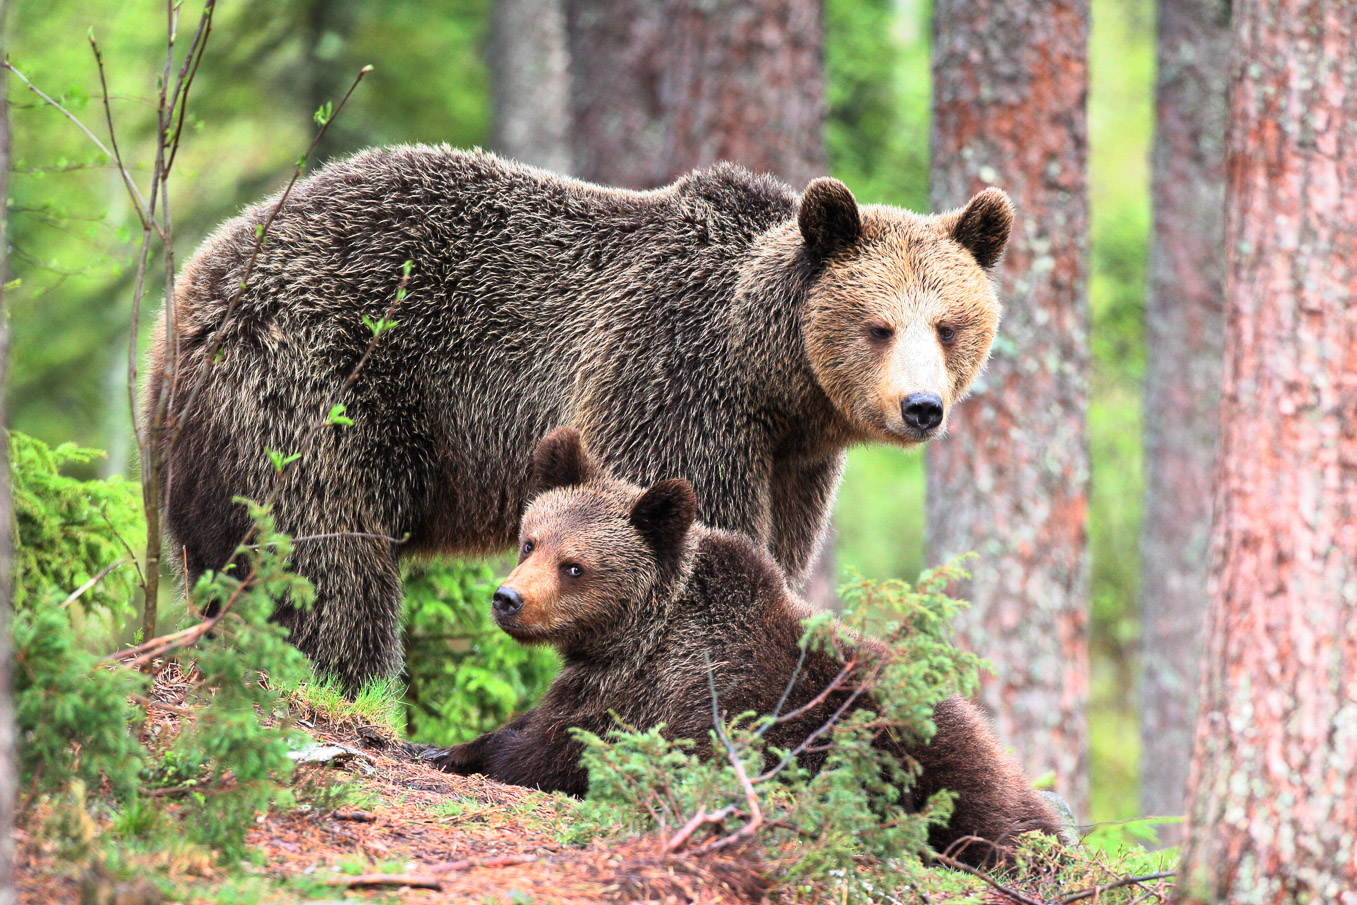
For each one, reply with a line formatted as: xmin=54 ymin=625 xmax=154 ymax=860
xmin=8 ymin=0 xmax=1155 ymax=821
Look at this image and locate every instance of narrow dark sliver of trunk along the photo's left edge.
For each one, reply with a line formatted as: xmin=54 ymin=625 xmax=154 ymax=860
xmin=0 ymin=0 xmax=19 ymax=905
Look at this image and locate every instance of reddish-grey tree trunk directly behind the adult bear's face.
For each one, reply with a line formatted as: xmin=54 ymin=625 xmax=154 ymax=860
xmin=927 ymin=0 xmax=1088 ymax=815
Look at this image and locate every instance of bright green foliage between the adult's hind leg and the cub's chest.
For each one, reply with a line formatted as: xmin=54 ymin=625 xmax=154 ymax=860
xmin=404 ymin=564 xmax=560 ymax=745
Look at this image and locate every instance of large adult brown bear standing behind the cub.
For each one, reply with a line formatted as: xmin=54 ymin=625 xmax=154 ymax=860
xmin=154 ymin=147 xmax=1012 ymax=688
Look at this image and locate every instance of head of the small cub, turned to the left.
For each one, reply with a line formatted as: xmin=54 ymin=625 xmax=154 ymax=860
xmin=491 ymin=429 xmax=696 ymax=650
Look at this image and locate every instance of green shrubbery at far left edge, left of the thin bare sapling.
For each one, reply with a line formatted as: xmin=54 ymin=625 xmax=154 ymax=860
xmin=9 ymin=431 xmax=145 ymax=795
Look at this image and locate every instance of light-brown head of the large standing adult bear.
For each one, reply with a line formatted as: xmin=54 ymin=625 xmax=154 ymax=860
xmin=801 ymin=180 xmax=1012 ymax=445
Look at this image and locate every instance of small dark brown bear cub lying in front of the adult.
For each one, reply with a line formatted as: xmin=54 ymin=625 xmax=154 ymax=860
xmin=429 ymin=429 xmax=1058 ymax=863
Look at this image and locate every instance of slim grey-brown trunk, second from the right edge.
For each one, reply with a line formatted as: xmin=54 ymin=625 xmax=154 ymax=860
xmin=1140 ymin=0 xmax=1229 ymax=844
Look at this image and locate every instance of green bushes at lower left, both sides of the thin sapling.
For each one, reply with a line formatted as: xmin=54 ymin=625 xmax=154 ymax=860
xmin=11 ymin=445 xmax=327 ymax=859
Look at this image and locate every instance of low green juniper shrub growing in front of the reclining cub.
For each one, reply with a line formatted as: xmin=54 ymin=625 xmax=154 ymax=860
xmin=566 ymin=564 xmax=978 ymax=902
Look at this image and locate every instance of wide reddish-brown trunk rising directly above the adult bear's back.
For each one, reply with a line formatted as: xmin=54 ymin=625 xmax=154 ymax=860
xmin=565 ymin=0 xmax=825 ymax=189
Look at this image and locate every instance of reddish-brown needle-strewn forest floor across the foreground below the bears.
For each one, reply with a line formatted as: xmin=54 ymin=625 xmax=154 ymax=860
xmin=16 ymin=670 xmax=1163 ymax=905
